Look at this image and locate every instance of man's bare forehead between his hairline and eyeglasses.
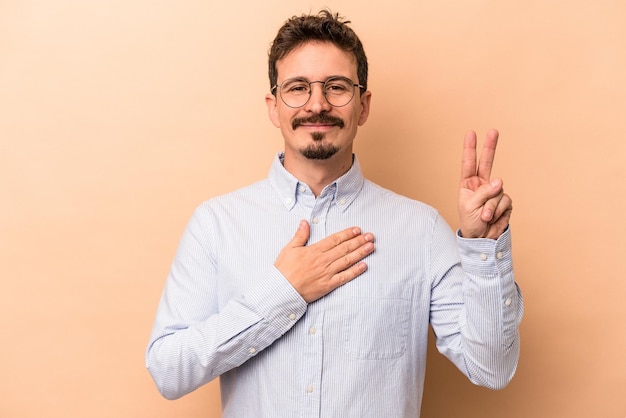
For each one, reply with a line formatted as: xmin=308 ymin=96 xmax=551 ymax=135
xmin=276 ymin=42 xmax=357 ymax=80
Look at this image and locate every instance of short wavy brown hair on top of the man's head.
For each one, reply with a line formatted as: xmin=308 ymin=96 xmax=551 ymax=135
xmin=269 ymin=10 xmax=367 ymax=94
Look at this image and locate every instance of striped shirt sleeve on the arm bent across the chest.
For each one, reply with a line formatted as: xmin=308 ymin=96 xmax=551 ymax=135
xmin=145 ymin=207 xmax=307 ymax=399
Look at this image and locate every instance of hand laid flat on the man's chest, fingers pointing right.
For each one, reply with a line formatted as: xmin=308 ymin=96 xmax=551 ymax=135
xmin=274 ymin=221 xmax=374 ymax=303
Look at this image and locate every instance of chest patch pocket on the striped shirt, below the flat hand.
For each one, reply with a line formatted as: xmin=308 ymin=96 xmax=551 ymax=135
xmin=342 ymin=282 xmax=411 ymax=360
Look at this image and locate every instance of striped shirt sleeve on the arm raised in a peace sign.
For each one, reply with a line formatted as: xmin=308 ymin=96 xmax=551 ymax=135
xmin=431 ymin=214 xmax=524 ymax=389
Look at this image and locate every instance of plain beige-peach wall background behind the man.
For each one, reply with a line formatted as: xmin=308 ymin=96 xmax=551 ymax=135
xmin=0 ymin=0 xmax=626 ymax=418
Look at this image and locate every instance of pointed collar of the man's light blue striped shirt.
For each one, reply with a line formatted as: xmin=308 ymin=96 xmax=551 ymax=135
xmin=269 ymin=152 xmax=365 ymax=210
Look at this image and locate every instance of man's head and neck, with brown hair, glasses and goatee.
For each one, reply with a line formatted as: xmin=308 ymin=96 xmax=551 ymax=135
xmin=265 ymin=11 xmax=371 ymax=167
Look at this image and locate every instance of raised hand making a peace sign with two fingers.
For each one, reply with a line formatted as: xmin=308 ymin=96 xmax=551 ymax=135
xmin=459 ymin=129 xmax=513 ymax=239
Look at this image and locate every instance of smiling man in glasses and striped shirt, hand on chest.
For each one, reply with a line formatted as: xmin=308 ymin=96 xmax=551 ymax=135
xmin=146 ymin=11 xmax=522 ymax=418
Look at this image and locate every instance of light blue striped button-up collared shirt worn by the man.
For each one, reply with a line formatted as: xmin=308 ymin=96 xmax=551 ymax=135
xmin=146 ymin=154 xmax=523 ymax=418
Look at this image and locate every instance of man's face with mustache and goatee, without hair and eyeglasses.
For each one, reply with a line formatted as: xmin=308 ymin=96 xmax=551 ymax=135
xmin=266 ymin=42 xmax=371 ymax=160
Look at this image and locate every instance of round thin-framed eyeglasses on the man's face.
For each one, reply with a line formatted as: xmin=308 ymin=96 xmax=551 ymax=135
xmin=271 ymin=77 xmax=364 ymax=108
